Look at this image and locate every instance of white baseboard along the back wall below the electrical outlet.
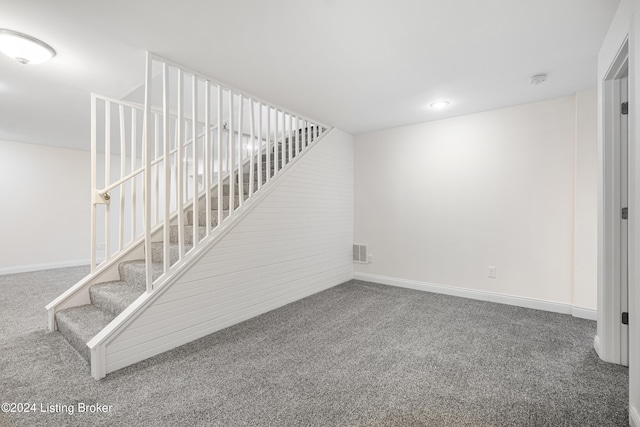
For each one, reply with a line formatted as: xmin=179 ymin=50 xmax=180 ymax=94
xmin=353 ymin=273 xmax=598 ymax=320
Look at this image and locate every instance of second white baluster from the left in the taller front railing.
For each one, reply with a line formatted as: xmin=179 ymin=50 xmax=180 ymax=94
xmin=165 ymin=62 xmax=171 ymax=274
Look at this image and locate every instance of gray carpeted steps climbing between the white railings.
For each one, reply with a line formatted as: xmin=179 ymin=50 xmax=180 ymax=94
xmin=55 ymin=144 xmax=298 ymax=362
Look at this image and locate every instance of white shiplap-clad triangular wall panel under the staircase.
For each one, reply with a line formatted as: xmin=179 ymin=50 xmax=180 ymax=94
xmin=106 ymin=129 xmax=354 ymax=373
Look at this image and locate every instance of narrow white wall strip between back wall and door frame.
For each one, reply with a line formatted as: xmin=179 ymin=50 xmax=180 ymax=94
xmin=572 ymin=88 xmax=598 ymax=309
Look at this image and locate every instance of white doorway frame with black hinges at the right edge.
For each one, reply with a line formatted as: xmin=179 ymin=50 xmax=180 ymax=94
xmin=598 ymin=41 xmax=630 ymax=366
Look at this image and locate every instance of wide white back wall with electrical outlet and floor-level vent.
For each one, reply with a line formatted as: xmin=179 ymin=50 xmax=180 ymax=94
xmin=355 ymin=96 xmax=596 ymax=317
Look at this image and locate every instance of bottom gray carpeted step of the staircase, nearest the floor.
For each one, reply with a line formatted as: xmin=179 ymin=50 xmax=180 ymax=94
xmin=56 ymin=305 xmax=116 ymax=362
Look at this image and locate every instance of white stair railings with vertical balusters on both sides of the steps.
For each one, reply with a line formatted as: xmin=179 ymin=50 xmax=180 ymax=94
xmin=91 ymin=53 xmax=328 ymax=292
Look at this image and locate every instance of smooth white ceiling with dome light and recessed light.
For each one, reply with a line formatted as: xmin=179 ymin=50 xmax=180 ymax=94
xmin=0 ymin=0 xmax=619 ymax=149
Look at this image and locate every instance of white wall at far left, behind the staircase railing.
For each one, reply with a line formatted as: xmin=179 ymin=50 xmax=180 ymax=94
xmin=0 ymin=141 xmax=90 ymax=274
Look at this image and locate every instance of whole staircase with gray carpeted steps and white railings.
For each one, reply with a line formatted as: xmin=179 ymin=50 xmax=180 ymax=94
xmin=46 ymin=53 xmax=330 ymax=379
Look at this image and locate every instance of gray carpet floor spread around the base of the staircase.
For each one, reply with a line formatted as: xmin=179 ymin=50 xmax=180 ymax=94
xmin=0 ymin=268 xmax=628 ymax=426
